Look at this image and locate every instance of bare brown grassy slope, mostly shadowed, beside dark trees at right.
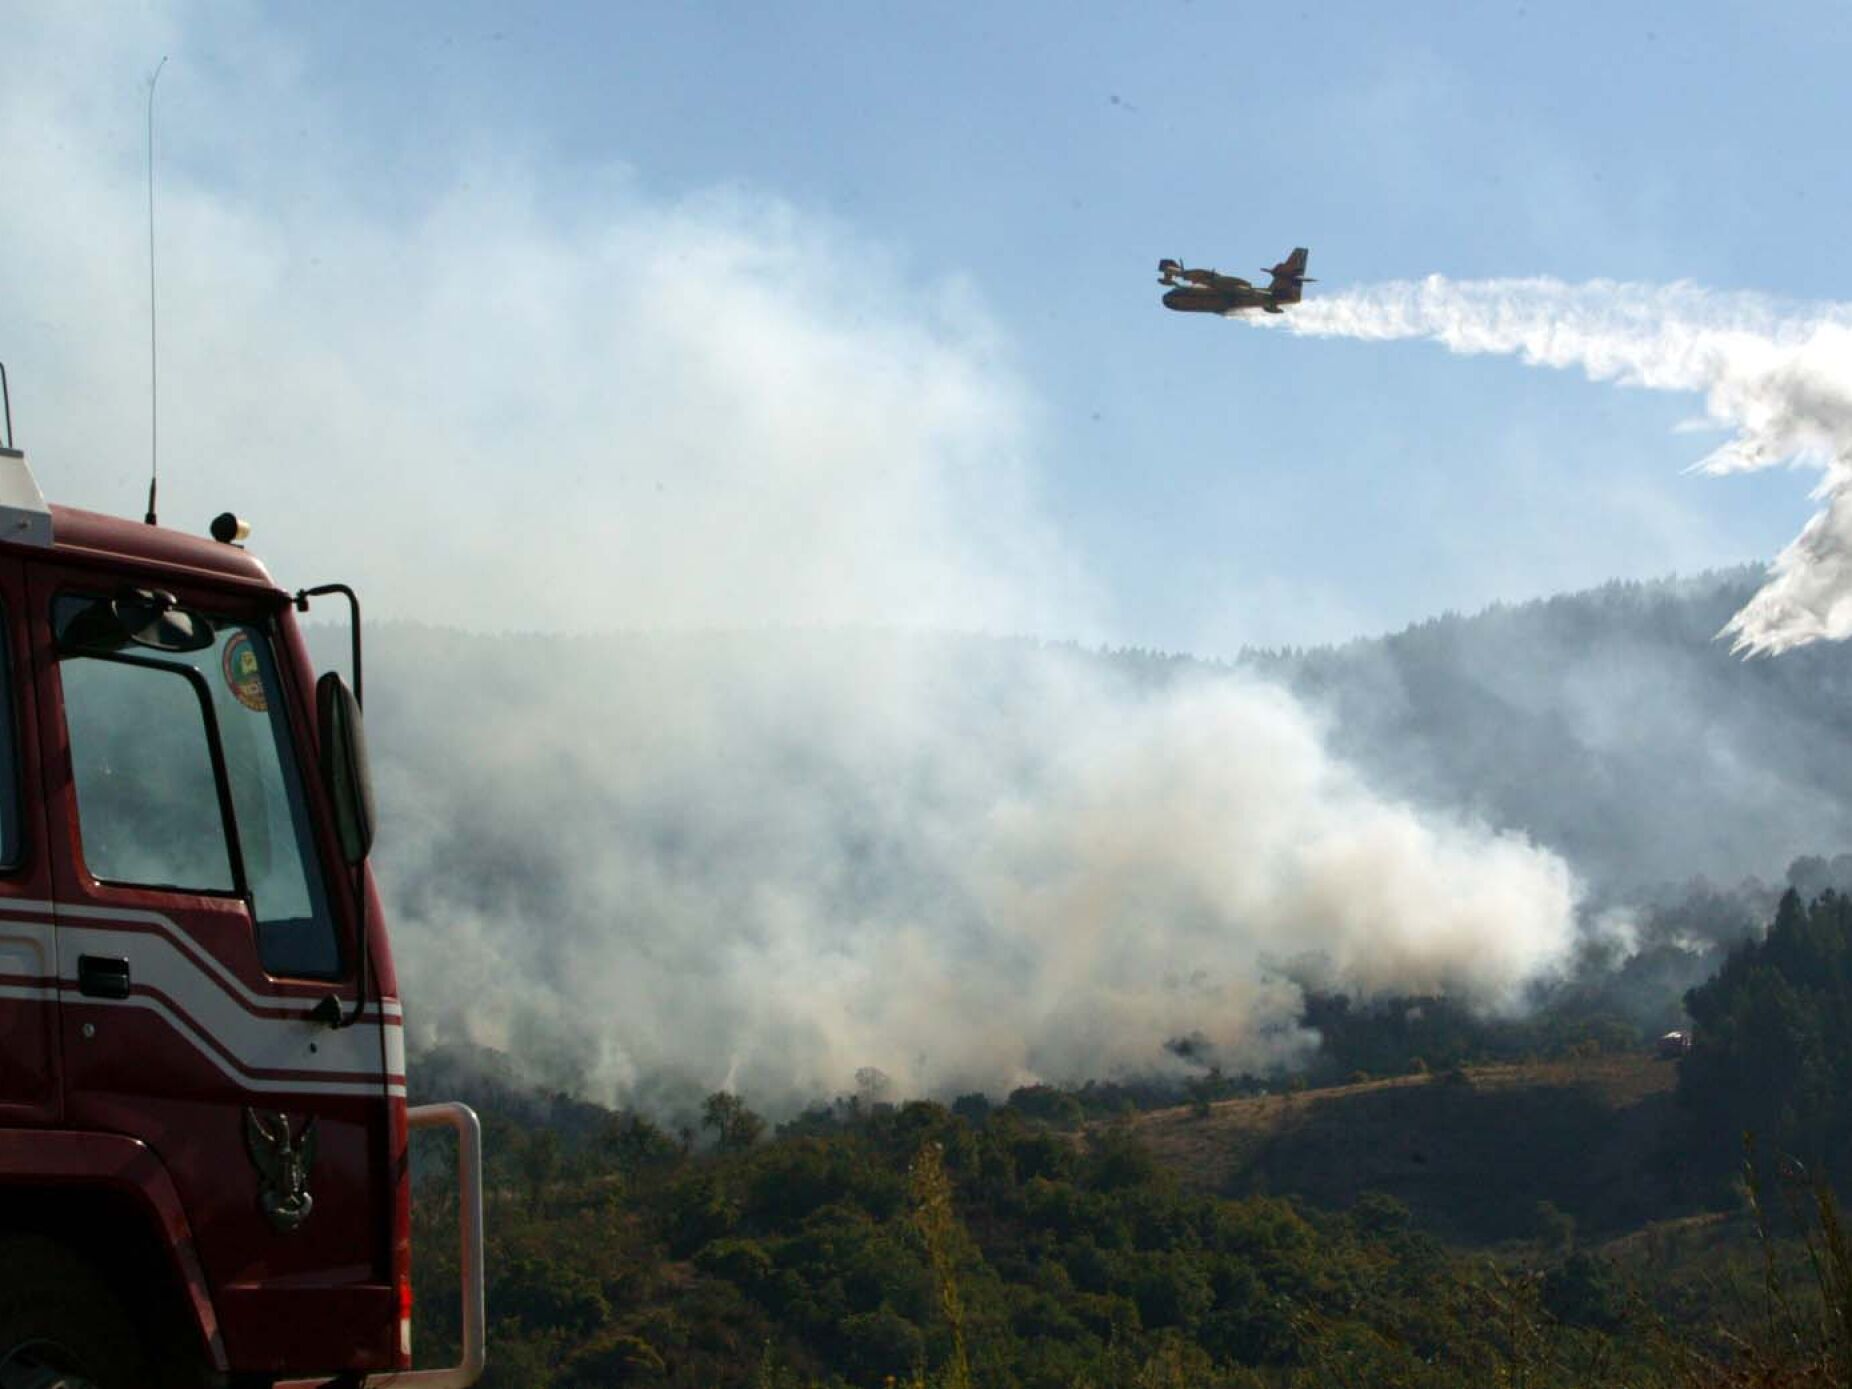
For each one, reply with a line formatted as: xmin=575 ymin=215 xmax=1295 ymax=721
xmin=1135 ymin=1056 xmax=1695 ymax=1245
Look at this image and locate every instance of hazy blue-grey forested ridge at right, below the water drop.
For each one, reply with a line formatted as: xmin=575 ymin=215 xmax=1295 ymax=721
xmin=1250 ymin=567 xmax=1852 ymax=902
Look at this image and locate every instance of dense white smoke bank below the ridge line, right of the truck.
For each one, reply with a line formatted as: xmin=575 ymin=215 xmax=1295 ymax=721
xmin=369 ymin=626 xmax=1576 ymax=1109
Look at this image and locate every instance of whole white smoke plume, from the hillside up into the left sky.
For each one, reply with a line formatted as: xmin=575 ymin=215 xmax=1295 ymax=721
xmin=0 ymin=11 xmax=1576 ymax=1104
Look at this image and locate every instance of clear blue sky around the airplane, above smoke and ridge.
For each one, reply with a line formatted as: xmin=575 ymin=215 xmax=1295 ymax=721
xmin=0 ymin=4 xmax=1852 ymax=654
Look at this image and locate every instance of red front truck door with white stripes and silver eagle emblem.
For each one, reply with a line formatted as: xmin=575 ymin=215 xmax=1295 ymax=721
xmin=28 ymin=567 xmax=393 ymax=1369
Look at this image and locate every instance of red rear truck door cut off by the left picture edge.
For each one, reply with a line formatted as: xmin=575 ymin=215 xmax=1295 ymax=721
xmin=0 ymin=559 xmax=61 ymax=1126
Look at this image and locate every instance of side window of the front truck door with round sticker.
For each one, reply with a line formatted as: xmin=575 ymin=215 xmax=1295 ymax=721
xmin=54 ymin=594 xmax=341 ymax=978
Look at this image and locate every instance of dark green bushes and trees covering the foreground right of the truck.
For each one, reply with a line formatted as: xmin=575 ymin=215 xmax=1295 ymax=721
xmin=415 ymin=1014 xmax=1852 ymax=1389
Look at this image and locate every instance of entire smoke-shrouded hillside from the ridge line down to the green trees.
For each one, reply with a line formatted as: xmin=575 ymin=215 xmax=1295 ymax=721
xmin=361 ymin=569 xmax=1852 ymax=1109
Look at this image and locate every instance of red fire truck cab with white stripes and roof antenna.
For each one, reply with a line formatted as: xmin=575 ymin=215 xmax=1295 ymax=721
xmin=0 ymin=372 xmax=483 ymax=1389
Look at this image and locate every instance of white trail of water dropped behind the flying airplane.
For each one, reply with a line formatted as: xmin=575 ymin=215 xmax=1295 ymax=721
xmin=1274 ymin=276 xmax=1852 ymax=654
